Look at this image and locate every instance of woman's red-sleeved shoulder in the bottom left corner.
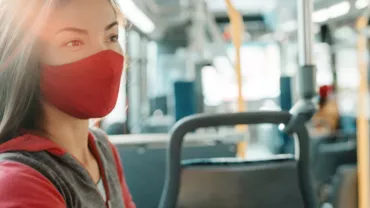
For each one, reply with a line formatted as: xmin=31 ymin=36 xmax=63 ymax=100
xmin=0 ymin=161 xmax=66 ymax=208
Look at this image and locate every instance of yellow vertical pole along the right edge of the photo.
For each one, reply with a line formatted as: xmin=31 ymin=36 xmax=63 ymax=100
xmin=356 ymin=16 xmax=370 ymax=208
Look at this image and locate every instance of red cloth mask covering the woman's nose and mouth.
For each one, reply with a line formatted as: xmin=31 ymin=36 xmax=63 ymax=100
xmin=40 ymin=50 xmax=124 ymax=119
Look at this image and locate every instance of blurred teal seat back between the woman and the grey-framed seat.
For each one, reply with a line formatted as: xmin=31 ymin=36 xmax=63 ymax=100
xmin=116 ymin=136 xmax=236 ymax=208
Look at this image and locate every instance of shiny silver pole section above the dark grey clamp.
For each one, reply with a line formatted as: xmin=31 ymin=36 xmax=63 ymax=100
xmin=297 ymin=0 xmax=313 ymax=66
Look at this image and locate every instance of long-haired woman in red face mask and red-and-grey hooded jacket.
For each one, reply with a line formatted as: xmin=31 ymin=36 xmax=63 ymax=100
xmin=0 ymin=0 xmax=135 ymax=208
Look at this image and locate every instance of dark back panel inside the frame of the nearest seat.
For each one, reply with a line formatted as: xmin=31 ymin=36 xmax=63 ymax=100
xmin=178 ymin=156 xmax=304 ymax=208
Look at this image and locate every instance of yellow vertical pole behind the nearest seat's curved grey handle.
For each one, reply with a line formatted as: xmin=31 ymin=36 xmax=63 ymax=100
xmin=225 ymin=0 xmax=247 ymax=158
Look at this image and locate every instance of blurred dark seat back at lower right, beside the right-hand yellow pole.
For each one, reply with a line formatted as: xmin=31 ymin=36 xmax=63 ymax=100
xmin=332 ymin=165 xmax=358 ymax=208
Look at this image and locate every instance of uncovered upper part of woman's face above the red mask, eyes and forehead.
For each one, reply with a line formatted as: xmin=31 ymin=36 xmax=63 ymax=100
xmin=40 ymin=0 xmax=122 ymax=65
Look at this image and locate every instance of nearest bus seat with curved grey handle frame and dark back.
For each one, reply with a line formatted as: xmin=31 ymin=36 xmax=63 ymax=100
xmin=159 ymin=111 xmax=317 ymax=208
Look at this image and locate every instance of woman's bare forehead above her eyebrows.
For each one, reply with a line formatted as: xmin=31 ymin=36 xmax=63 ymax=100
xmin=45 ymin=0 xmax=117 ymax=32
